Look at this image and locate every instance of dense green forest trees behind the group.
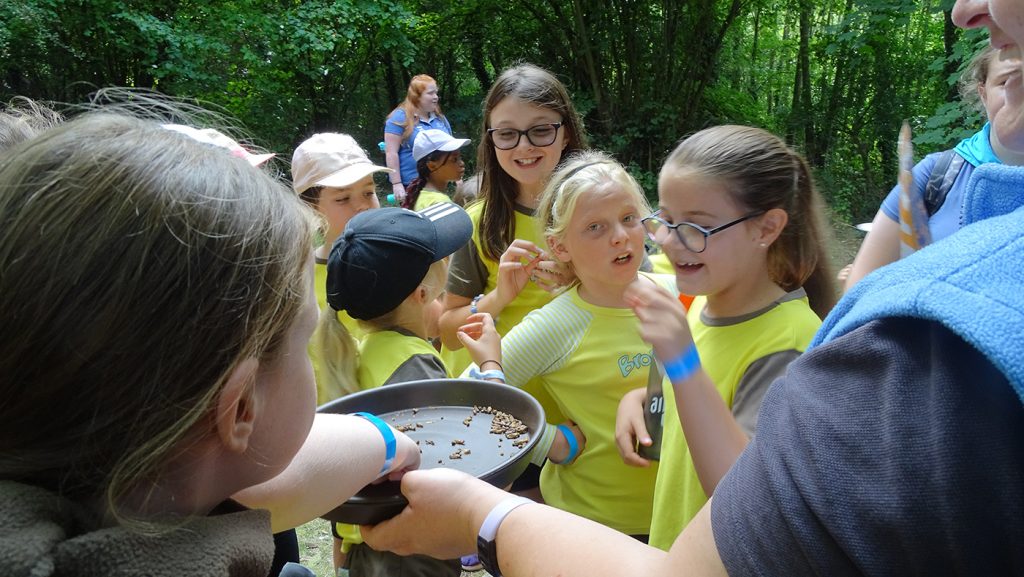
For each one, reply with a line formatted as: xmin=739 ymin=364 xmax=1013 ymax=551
xmin=0 ymin=0 xmax=987 ymax=222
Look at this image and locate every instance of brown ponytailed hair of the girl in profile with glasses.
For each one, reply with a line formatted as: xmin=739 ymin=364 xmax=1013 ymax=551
xmin=662 ymin=125 xmax=837 ymax=319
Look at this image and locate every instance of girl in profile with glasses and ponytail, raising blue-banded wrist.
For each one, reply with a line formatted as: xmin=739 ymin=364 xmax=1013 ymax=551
xmin=616 ymin=126 xmax=836 ymax=549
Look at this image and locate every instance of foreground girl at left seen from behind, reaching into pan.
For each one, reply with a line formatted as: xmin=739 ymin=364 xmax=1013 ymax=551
xmin=0 ymin=112 xmax=419 ymax=576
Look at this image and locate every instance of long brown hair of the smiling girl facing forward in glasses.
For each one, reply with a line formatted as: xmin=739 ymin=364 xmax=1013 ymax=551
xmin=476 ymin=64 xmax=587 ymax=260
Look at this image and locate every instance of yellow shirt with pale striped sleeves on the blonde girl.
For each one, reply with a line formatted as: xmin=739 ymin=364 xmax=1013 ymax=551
xmin=502 ymin=274 xmax=676 ymax=535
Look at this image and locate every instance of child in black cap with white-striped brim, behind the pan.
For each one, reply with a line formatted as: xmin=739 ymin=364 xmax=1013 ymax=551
xmin=317 ymin=203 xmax=483 ymax=577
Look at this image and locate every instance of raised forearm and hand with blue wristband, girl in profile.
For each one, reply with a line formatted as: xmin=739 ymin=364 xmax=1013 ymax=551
xmin=627 ymin=279 xmax=750 ymax=495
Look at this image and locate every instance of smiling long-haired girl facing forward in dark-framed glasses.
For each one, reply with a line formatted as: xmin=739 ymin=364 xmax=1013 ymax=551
xmin=440 ymin=65 xmax=587 ymax=422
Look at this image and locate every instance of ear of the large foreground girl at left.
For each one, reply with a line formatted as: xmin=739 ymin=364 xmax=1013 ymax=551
xmin=216 ymin=359 xmax=261 ymax=453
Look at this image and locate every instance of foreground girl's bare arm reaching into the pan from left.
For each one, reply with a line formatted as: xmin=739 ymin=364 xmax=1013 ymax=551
xmin=234 ymin=414 xmax=420 ymax=533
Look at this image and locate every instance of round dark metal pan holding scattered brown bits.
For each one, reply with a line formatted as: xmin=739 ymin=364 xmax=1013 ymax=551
xmin=317 ymin=378 xmax=545 ymax=525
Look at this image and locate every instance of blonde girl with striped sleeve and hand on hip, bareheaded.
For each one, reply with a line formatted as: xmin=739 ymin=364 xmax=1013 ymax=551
xmin=463 ymin=152 xmax=674 ymax=540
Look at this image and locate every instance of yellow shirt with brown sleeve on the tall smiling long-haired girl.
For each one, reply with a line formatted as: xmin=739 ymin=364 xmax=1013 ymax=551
xmin=441 ymin=201 xmax=565 ymax=423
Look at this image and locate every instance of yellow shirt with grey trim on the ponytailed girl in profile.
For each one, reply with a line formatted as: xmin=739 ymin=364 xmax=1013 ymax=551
xmin=650 ymin=288 xmax=821 ymax=550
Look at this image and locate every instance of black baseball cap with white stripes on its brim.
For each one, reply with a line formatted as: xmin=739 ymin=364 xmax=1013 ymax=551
xmin=327 ymin=202 xmax=473 ymax=321
